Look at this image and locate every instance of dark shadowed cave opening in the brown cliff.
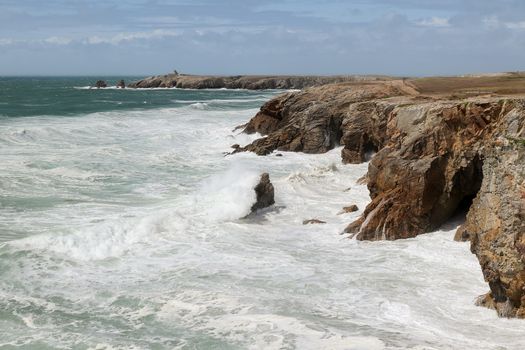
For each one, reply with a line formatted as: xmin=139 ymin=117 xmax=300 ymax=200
xmin=451 ymin=155 xmax=483 ymax=220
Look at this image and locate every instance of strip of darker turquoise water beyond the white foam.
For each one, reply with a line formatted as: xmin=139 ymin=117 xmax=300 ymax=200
xmin=0 ymin=77 xmax=268 ymax=118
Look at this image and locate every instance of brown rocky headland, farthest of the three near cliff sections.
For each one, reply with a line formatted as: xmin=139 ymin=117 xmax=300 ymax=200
xmin=235 ymin=82 xmax=412 ymax=156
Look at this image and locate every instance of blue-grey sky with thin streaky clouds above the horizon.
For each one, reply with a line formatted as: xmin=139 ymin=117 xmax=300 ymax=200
xmin=0 ymin=0 xmax=525 ymax=76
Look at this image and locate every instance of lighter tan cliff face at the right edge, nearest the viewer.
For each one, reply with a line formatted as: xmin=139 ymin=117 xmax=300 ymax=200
xmin=463 ymin=119 xmax=525 ymax=318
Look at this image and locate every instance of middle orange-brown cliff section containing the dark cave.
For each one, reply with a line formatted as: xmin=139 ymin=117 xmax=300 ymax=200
xmin=346 ymin=100 xmax=504 ymax=240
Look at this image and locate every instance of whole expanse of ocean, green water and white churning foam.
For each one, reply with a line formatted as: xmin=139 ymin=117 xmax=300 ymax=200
xmin=0 ymin=77 xmax=525 ymax=350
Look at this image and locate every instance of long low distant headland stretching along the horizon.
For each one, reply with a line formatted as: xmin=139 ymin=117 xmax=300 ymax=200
xmin=128 ymin=74 xmax=389 ymax=90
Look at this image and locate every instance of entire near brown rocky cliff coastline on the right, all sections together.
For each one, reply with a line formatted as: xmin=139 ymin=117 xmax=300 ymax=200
xmin=235 ymin=77 xmax=525 ymax=318
